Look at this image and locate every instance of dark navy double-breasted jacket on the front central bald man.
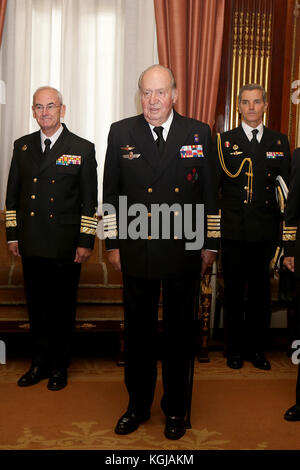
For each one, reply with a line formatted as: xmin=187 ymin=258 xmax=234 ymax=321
xmin=103 ymin=111 xmax=220 ymax=279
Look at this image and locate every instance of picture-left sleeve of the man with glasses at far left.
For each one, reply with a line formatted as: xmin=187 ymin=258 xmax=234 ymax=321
xmin=5 ymin=144 xmax=21 ymax=242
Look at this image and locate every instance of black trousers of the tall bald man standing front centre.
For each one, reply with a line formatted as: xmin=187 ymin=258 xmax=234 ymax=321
xmin=123 ymin=275 xmax=199 ymax=417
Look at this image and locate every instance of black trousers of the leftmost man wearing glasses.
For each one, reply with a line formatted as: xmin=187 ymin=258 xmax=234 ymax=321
xmin=22 ymin=257 xmax=81 ymax=369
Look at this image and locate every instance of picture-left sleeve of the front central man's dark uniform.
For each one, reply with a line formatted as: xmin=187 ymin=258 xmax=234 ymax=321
xmin=103 ymin=125 xmax=120 ymax=250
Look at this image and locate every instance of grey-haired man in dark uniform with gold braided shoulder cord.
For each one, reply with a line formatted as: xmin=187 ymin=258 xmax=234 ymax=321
xmin=216 ymin=84 xmax=290 ymax=370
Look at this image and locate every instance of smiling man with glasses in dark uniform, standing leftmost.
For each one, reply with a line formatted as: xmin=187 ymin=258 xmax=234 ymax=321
xmin=6 ymin=87 xmax=97 ymax=390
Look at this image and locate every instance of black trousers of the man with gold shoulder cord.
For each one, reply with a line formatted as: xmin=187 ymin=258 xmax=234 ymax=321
xmin=221 ymin=240 xmax=275 ymax=355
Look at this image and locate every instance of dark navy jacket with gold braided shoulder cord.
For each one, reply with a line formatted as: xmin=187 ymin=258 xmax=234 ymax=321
xmin=215 ymin=125 xmax=290 ymax=242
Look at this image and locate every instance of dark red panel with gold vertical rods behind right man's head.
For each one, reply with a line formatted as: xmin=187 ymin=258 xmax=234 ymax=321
xmin=214 ymin=0 xmax=294 ymax=136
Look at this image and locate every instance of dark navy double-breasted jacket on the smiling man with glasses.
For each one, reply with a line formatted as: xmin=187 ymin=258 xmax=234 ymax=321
xmin=6 ymin=124 xmax=97 ymax=259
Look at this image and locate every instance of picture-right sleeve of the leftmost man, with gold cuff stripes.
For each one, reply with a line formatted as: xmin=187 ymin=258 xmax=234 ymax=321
xmin=78 ymin=144 xmax=98 ymax=249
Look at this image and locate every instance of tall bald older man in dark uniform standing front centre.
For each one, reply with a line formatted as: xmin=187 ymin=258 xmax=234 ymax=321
xmin=103 ymin=65 xmax=219 ymax=439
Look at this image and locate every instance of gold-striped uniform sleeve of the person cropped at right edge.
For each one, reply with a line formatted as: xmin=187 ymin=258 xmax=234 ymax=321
xmin=283 ymin=149 xmax=300 ymax=256
